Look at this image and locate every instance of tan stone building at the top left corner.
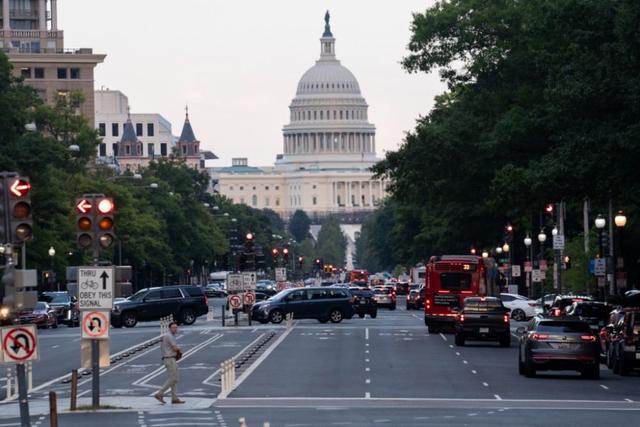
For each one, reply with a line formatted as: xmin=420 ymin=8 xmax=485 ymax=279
xmin=0 ymin=0 xmax=106 ymax=126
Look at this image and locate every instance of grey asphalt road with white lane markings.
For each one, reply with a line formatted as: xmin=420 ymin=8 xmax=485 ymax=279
xmin=0 ymin=300 xmax=640 ymax=427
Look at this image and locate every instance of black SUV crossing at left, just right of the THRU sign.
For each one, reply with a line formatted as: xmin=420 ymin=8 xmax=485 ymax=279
xmin=111 ymin=285 xmax=209 ymax=328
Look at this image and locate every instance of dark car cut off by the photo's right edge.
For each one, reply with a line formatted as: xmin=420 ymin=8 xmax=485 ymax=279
xmin=607 ymin=307 xmax=640 ymax=375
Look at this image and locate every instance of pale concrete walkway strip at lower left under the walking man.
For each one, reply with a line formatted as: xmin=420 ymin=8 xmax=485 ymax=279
xmin=0 ymin=396 xmax=216 ymax=419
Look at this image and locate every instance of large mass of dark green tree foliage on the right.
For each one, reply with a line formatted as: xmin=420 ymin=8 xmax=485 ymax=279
xmin=364 ymin=0 xmax=640 ymax=288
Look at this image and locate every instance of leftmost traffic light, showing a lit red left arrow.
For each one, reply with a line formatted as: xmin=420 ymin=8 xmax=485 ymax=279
xmin=5 ymin=176 xmax=33 ymax=244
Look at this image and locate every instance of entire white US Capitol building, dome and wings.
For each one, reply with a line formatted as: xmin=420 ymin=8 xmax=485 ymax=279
xmin=210 ymin=12 xmax=386 ymax=224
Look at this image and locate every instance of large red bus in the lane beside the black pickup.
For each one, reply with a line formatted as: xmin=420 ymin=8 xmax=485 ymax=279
xmin=424 ymin=255 xmax=487 ymax=332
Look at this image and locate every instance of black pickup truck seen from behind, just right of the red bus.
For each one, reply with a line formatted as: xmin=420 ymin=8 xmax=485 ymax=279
xmin=455 ymin=297 xmax=511 ymax=347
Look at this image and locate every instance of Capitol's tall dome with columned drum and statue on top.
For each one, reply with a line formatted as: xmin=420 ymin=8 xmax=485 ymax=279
xmin=277 ymin=12 xmax=377 ymax=169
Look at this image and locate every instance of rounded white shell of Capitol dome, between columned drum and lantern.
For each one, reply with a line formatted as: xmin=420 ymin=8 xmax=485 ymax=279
xmin=296 ymin=60 xmax=360 ymax=95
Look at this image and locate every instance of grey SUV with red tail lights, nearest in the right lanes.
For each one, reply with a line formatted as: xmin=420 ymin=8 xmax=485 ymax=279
xmin=516 ymin=316 xmax=600 ymax=379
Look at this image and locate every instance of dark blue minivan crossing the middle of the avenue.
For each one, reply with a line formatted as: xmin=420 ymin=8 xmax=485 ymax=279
xmin=251 ymin=287 xmax=355 ymax=324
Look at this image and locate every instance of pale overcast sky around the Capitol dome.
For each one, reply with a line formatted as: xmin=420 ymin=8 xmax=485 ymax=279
xmin=58 ymin=0 xmax=445 ymax=166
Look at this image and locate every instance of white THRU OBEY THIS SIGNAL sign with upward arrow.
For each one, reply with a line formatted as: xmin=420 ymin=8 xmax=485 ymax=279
xmin=78 ymin=267 xmax=115 ymax=311
